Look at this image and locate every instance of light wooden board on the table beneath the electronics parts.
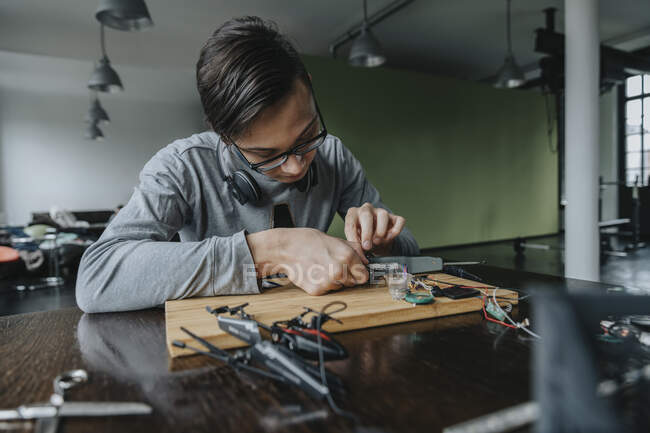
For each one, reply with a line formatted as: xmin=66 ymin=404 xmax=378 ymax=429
xmin=165 ymin=273 xmax=518 ymax=358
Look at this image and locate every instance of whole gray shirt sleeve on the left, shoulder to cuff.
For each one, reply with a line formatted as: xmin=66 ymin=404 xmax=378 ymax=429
xmin=76 ymin=150 xmax=259 ymax=313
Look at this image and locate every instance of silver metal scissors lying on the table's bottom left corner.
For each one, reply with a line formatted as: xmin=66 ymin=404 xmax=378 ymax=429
xmin=0 ymin=370 xmax=151 ymax=424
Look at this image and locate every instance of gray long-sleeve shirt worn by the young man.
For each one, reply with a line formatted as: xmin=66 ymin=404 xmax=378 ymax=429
xmin=76 ymin=132 xmax=419 ymax=312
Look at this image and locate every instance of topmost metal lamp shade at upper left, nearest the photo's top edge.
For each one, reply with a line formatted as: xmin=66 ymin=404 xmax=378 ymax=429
xmin=95 ymin=0 xmax=153 ymax=31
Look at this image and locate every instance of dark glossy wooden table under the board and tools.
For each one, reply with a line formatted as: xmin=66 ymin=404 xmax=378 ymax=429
xmin=0 ymin=266 xmax=606 ymax=433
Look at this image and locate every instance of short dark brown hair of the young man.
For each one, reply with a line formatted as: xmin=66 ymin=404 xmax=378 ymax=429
xmin=196 ymin=16 xmax=309 ymax=142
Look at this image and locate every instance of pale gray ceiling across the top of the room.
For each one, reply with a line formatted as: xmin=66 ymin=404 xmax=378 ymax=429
xmin=0 ymin=0 xmax=650 ymax=80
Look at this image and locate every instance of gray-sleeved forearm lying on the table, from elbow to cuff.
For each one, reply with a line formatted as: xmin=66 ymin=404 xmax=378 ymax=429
xmin=77 ymin=232 xmax=259 ymax=312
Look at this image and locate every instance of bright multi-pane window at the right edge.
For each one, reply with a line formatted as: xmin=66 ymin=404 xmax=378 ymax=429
xmin=624 ymin=75 xmax=650 ymax=185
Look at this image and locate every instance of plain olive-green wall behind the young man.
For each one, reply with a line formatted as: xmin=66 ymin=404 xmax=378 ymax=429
xmin=304 ymin=56 xmax=558 ymax=248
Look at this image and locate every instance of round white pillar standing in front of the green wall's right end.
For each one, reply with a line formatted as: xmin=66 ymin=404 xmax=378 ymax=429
xmin=564 ymin=0 xmax=600 ymax=281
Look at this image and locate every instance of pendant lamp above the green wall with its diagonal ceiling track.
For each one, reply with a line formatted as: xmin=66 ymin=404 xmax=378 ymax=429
xmin=329 ymin=0 xmax=413 ymax=67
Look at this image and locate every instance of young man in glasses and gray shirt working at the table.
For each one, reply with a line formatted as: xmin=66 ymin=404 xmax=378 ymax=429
xmin=76 ymin=17 xmax=419 ymax=312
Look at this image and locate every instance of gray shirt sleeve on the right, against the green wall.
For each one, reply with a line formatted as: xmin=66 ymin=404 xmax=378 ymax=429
xmin=337 ymin=140 xmax=420 ymax=256
